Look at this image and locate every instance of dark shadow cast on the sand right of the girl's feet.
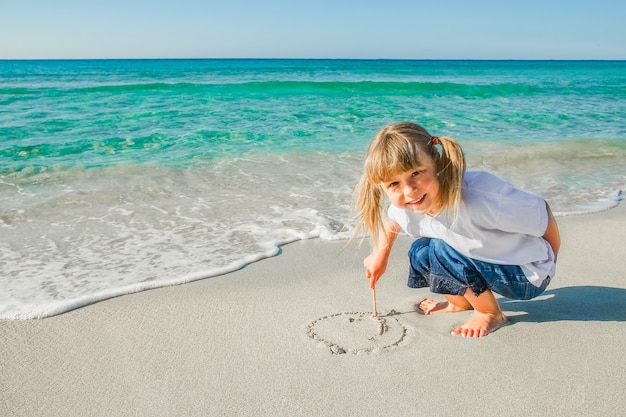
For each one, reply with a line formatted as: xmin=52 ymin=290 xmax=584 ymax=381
xmin=499 ymin=286 xmax=626 ymax=323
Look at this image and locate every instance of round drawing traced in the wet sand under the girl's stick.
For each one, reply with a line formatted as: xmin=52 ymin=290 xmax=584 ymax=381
xmin=307 ymin=310 xmax=407 ymax=355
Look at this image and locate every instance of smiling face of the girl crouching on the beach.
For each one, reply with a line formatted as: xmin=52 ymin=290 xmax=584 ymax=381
xmin=382 ymin=161 xmax=441 ymax=216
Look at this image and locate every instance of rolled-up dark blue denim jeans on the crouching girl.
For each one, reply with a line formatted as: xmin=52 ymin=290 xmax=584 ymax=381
xmin=408 ymin=238 xmax=550 ymax=300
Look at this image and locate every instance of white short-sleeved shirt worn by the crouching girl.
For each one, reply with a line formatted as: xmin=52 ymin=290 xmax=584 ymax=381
xmin=388 ymin=172 xmax=556 ymax=287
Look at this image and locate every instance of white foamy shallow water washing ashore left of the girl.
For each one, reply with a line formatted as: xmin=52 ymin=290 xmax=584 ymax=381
xmin=0 ymin=158 xmax=358 ymax=318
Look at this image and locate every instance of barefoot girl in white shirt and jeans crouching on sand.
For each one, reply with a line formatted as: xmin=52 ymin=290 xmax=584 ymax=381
xmin=355 ymin=123 xmax=560 ymax=337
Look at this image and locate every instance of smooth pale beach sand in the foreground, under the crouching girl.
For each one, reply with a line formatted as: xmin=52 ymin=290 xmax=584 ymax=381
xmin=0 ymin=205 xmax=626 ymax=417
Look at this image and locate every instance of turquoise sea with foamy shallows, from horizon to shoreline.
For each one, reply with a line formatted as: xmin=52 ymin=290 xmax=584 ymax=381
xmin=0 ymin=59 xmax=626 ymax=319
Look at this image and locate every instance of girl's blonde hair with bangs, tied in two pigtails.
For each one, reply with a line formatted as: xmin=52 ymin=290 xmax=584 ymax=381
xmin=353 ymin=122 xmax=465 ymax=244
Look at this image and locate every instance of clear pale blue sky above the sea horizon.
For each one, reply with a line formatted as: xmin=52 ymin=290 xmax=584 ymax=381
xmin=0 ymin=0 xmax=626 ymax=59
